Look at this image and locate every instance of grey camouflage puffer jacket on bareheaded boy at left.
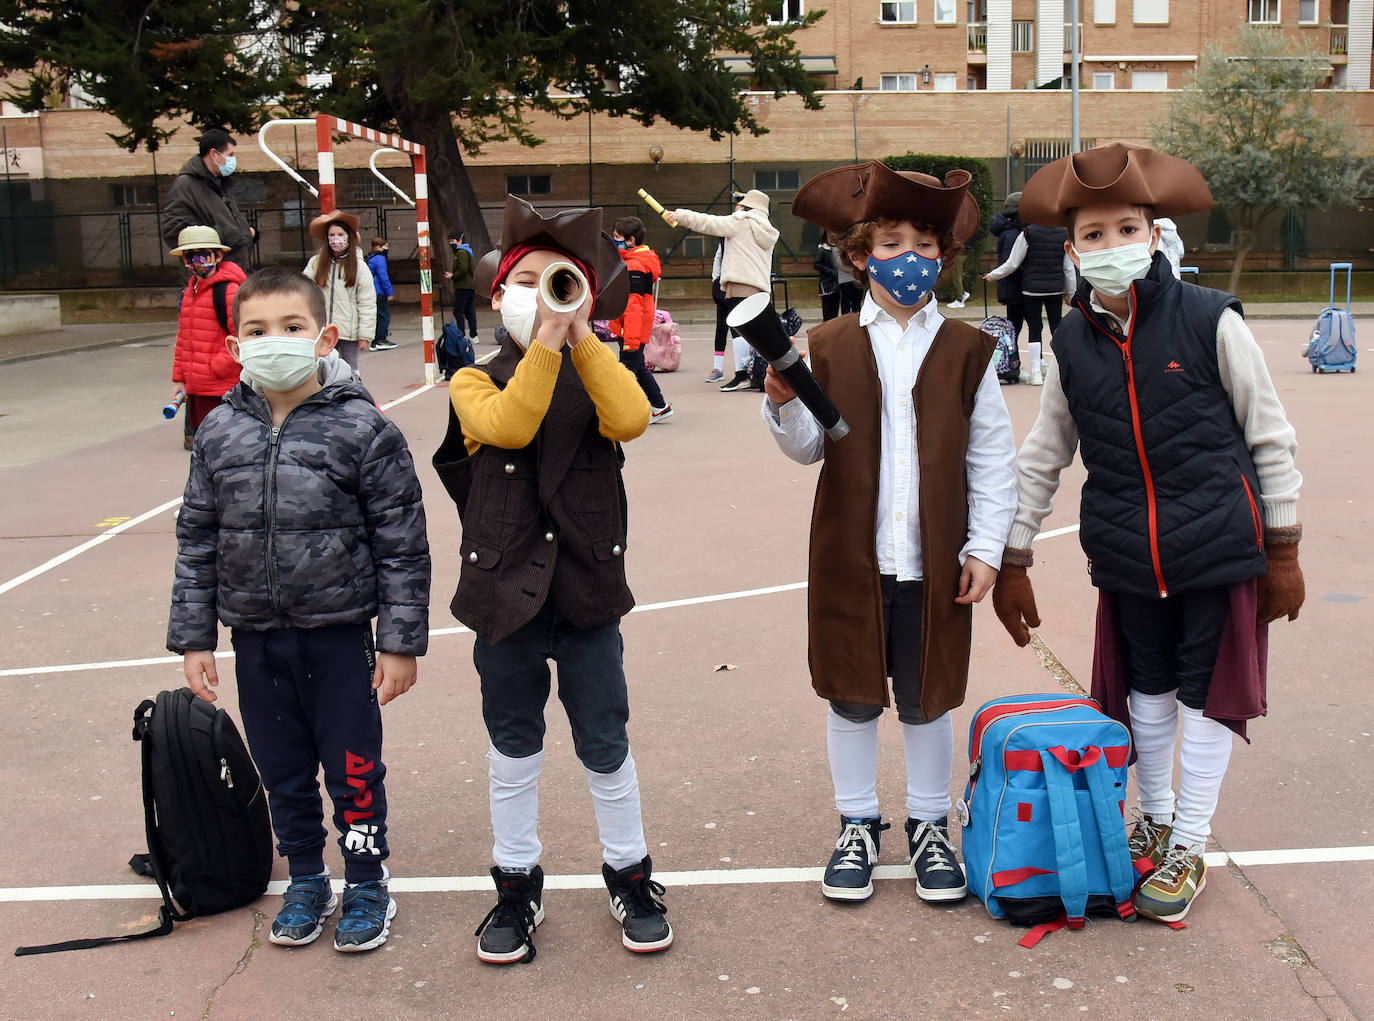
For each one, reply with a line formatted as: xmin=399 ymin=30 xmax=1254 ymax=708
xmin=168 ymin=371 xmax=430 ymax=655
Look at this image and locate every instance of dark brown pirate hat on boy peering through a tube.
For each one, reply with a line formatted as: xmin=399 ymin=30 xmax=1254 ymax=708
xmin=474 ymin=195 xmax=629 ymax=319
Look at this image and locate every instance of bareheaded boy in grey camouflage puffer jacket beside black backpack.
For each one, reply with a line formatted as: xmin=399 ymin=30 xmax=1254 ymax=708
xmin=168 ymin=269 xmax=430 ymax=951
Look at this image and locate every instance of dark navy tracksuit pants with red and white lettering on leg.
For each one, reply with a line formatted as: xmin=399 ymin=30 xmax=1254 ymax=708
xmin=232 ymin=622 xmax=387 ymax=884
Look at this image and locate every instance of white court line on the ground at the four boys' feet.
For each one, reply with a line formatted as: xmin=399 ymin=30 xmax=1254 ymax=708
xmin=0 ymin=845 xmax=1374 ymax=904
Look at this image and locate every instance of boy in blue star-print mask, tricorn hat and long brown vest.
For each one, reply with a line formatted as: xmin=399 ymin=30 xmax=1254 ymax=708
xmin=764 ymin=161 xmax=1015 ymax=901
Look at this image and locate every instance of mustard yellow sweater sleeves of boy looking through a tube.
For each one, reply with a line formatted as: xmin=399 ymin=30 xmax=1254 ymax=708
xmin=448 ymin=335 xmax=649 ymax=453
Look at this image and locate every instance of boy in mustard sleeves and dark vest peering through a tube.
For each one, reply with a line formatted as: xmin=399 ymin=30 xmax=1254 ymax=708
xmin=434 ymin=197 xmax=673 ymax=965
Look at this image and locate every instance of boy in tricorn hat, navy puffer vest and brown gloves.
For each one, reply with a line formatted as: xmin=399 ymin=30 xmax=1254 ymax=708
xmin=993 ymin=144 xmax=1304 ymax=922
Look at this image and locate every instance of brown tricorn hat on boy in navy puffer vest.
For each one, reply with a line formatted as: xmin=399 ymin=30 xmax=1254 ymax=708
xmin=1021 ymin=142 xmax=1212 ymax=227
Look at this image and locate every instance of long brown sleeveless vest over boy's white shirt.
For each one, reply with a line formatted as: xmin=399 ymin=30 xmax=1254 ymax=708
xmin=807 ymin=315 xmax=993 ymax=720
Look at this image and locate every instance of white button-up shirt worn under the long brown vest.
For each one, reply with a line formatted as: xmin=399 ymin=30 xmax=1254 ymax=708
xmin=763 ymin=295 xmax=1017 ymax=581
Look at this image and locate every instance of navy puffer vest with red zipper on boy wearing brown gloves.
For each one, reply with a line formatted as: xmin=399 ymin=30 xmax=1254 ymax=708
xmin=1052 ymin=254 xmax=1264 ymax=596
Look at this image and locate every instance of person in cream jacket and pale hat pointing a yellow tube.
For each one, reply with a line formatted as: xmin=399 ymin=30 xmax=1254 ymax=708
xmin=672 ymin=188 xmax=778 ymax=392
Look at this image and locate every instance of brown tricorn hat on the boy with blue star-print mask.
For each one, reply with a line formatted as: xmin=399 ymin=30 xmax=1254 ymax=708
xmin=791 ymin=159 xmax=980 ymax=245
